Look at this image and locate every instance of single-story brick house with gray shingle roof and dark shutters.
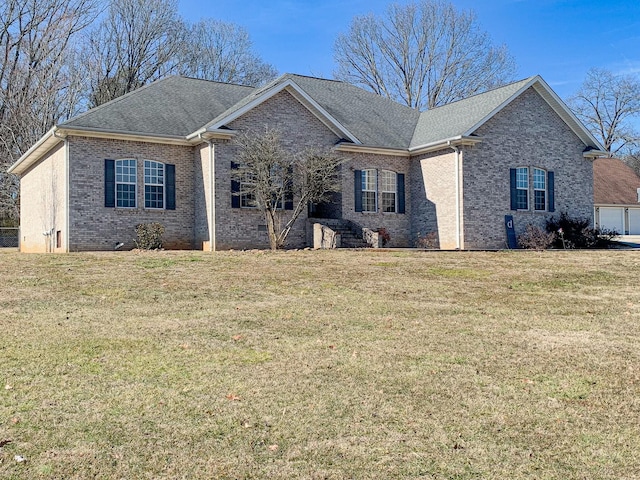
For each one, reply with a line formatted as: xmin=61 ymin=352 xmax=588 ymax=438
xmin=10 ymin=74 xmax=604 ymax=251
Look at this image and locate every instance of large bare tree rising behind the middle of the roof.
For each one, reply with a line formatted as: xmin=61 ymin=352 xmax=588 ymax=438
xmin=334 ymin=0 xmax=515 ymax=109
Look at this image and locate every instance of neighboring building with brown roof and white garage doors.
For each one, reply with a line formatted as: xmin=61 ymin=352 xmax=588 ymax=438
xmin=593 ymin=158 xmax=640 ymax=235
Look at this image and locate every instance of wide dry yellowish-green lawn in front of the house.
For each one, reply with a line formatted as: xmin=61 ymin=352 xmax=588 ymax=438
xmin=0 ymin=250 xmax=640 ymax=479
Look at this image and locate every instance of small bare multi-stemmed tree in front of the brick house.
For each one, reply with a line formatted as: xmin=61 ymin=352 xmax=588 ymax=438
xmin=232 ymin=128 xmax=344 ymax=250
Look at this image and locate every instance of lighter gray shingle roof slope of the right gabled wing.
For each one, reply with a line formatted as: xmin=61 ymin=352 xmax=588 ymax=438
xmin=410 ymin=77 xmax=533 ymax=148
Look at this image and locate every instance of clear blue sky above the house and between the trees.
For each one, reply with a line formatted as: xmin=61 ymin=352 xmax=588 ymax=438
xmin=179 ymin=0 xmax=640 ymax=98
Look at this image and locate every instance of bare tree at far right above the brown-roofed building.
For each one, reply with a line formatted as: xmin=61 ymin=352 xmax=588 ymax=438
xmin=568 ymin=68 xmax=640 ymax=156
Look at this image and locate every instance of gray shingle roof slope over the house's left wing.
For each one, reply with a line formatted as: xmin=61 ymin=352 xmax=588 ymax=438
xmin=61 ymin=77 xmax=254 ymax=136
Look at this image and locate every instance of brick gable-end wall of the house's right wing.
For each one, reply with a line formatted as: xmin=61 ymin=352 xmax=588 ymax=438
xmin=463 ymin=89 xmax=593 ymax=248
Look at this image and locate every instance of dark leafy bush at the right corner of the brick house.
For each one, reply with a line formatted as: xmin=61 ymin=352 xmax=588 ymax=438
xmin=547 ymin=212 xmax=620 ymax=249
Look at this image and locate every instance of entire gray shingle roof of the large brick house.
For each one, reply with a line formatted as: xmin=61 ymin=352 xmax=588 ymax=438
xmin=61 ymin=74 xmax=548 ymax=149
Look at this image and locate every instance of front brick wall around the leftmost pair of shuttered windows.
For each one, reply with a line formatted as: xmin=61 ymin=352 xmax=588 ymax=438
xmin=69 ymin=136 xmax=195 ymax=251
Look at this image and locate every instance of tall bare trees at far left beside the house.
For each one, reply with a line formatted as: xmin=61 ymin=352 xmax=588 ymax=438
xmin=0 ymin=0 xmax=97 ymax=219
